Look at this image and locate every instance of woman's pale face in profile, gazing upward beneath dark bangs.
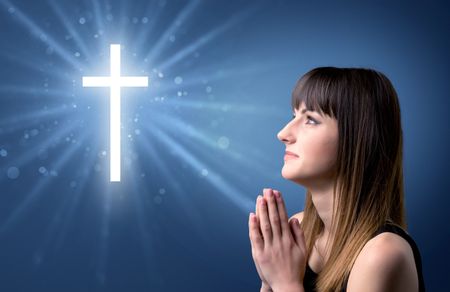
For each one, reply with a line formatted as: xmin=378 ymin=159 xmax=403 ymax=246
xmin=277 ymin=102 xmax=339 ymax=187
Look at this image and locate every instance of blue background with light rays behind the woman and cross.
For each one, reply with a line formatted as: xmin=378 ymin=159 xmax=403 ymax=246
xmin=0 ymin=0 xmax=450 ymax=291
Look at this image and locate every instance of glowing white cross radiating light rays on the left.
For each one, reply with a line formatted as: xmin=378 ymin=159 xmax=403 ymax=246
xmin=83 ymin=44 xmax=148 ymax=182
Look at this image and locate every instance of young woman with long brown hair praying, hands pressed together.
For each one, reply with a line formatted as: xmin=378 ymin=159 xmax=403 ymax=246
xmin=249 ymin=67 xmax=425 ymax=292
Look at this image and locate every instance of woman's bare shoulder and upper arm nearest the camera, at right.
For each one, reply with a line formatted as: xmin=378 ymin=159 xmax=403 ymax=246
xmin=347 ymin=232 xmax=419 ymax=292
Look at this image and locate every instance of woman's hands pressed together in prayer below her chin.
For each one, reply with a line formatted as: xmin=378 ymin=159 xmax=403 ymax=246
xmin=249 ymin=189 xmax=307 ymax=292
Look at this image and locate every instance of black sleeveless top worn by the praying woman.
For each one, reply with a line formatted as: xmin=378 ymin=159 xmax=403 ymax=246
xmin=303 ymin=221 xmax=425 ymax=292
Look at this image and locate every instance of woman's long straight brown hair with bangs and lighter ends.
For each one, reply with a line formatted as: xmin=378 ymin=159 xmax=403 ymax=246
xmin=292 ymin=67 xmax=406 ymax=292
